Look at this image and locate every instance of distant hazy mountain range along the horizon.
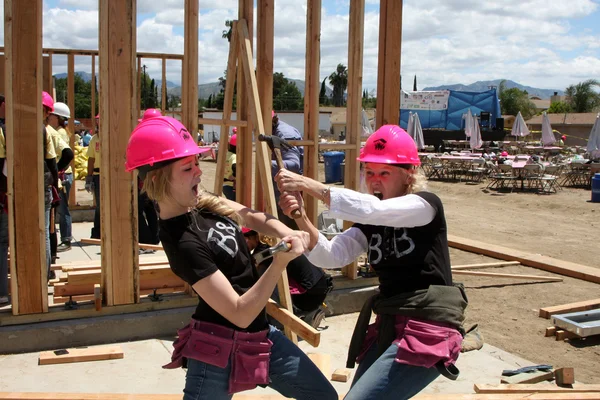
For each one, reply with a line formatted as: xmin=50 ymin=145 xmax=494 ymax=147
xmin=54 ymin=71 xmax=564 ymax=99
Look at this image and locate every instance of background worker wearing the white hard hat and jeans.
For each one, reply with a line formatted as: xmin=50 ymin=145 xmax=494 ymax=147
xmin=48 ymin=102 xmax=73 ymax=252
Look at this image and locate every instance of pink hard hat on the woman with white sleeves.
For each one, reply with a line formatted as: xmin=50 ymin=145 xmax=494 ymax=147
xmin=357 ymin=125 xmax=421 ymax=166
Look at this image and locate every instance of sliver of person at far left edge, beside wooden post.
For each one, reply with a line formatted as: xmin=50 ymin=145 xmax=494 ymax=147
xmin=0 ymin=95 xmax=10 ymax=306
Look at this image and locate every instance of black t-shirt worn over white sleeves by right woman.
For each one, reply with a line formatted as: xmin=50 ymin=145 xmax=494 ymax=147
xmin=354 ymin=192 xmax=452 ymax=297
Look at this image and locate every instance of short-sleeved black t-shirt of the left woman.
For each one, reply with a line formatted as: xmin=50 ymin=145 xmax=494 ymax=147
xmin=159 ymin=210 xmax=268 ymax=332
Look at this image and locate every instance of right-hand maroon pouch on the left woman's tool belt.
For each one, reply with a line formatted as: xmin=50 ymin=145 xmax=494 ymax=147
xmin=229 ymin=330 xmax=273 ymax=394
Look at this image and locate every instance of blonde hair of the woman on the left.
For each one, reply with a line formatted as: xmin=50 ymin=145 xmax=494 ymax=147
xmin=143 ymin=164 xmax=242 ymax=225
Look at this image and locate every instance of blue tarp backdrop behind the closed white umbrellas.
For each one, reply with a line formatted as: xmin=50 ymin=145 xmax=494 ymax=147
xmin=400 ymin=89 xmax=502 ymax=130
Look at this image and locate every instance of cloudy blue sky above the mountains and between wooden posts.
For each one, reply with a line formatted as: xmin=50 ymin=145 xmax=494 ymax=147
xmin=0 ymin=0 xmax=600 ymax=94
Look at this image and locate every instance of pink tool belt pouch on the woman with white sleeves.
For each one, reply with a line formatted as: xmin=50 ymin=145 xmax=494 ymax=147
xmin=394 ymin=317 xmax=462 ymax=368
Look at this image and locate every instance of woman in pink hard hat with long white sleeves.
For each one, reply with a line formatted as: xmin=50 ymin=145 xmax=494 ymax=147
xmin=276 ymin=125 xmax=467 ymax=400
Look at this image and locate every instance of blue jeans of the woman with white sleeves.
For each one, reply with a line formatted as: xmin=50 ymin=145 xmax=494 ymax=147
xmin=344 ymin=343 xmax=440 ymax=400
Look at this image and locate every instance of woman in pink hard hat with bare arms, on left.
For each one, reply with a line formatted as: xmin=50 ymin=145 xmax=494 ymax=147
xmin=126 ymin=117 xmax=338 ymax=400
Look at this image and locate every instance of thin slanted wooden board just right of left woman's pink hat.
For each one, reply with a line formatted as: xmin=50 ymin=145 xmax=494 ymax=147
xmin=212 ymin=21 xmax=238 ymax=196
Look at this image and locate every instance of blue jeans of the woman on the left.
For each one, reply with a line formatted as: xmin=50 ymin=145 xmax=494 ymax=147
xmin=183 ymin=327 xmax=338 ymax=400
